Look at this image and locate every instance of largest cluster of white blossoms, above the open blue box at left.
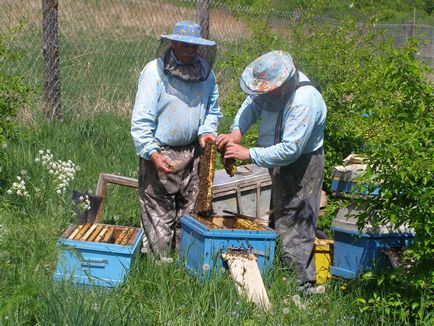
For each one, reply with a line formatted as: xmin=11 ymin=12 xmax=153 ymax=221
xmin=35 ymin=149 xmax=80 ymax=195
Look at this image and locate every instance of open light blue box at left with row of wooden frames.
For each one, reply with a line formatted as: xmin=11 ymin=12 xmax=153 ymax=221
xmin=54 ymin=224 xmax=143 ymax=287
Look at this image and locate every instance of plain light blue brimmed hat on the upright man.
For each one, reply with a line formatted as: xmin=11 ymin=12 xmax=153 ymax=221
xmin=160 ymin=20 xmax=216 ymax=46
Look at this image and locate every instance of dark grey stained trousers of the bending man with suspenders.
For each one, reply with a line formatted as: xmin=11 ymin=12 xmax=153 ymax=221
xmin=269 ymin=148 xmax=324 ymax=285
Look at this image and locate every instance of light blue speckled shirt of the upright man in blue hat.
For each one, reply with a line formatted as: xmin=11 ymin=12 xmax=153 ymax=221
xmin=131 ymin=59 xmax=222 ymax=160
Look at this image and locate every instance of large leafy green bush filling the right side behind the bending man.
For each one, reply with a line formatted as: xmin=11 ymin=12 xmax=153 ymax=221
xmin=290 ymin=15 xmax=434 ymax=319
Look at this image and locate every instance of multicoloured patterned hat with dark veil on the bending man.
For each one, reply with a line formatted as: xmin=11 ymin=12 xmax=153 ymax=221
xmin=240 ymin=51 xmax=298 ymax=112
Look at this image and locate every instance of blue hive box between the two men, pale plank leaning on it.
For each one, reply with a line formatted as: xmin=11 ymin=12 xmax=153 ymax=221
xmin=180 ymin=215 xmax=277 ymax=278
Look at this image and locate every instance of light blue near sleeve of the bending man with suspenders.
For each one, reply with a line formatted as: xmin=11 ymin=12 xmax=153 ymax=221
xmin=249 ymin=105 xmax=315 ymax=168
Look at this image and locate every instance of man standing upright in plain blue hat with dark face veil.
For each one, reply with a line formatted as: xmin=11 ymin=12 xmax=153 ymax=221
xmin=131 ymin=21 xmax=222 ymax=255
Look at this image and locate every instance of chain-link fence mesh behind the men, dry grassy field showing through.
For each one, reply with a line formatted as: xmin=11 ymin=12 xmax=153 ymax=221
xmin=0 ymin=0 xmax=434 ymax=117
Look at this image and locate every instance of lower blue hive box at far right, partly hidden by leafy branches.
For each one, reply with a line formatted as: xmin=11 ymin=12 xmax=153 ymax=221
xmin=330 ymin=206 xmax=414 ymax=279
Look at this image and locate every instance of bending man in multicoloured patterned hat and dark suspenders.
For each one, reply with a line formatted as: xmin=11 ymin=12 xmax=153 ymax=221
xmin=216 ymin=51 xmax=327 ymax=293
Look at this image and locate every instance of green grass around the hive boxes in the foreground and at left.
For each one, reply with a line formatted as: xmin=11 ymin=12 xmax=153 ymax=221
xmin=0 ymin=114 xmax=403 ymax=325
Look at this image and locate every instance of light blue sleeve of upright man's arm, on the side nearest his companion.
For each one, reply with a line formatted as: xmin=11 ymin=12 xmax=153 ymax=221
xmin=198 ymin=73 xmax=223 ymax=136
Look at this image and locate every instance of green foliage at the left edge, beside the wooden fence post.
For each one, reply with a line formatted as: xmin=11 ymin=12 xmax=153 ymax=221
xmin=0 ymin=28 xmax=30 ymax=186
